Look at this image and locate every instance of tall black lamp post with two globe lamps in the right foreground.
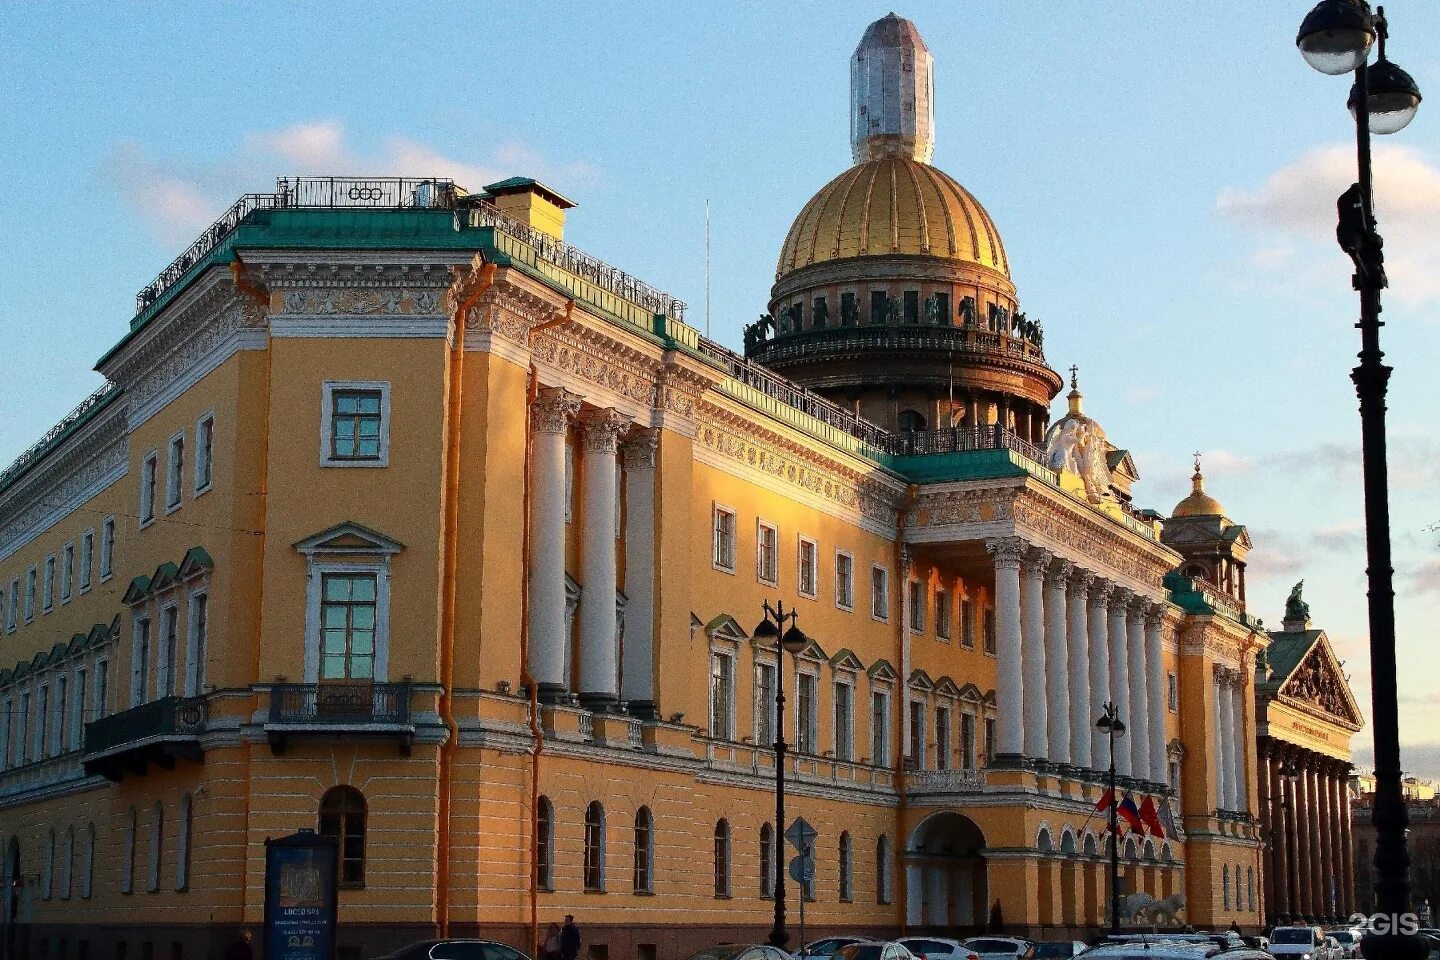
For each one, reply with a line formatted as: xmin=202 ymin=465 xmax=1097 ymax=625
xmin=1295 ymin=0 xmax=1424 ymax=960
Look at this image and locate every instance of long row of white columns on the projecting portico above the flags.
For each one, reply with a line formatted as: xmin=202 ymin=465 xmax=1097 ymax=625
xmin=985 ymin=537 xmax=1169 ymax=786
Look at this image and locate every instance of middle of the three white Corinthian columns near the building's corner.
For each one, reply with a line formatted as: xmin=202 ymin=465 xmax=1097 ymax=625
xmin=580 ymin=409 xmax=629 ymax=710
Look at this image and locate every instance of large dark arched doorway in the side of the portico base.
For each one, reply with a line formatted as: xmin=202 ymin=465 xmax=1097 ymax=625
xmin=904 ymin=810 xmax=988 ymax=931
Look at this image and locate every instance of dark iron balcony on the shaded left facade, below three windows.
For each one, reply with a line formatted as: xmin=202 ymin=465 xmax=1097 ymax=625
xmin=82 ymin=697 xmax=206 ymax=782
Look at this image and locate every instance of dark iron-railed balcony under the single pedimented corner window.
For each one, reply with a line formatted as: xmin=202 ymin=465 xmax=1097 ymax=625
xmin=265 ymin=681 xmax=415 ymax=754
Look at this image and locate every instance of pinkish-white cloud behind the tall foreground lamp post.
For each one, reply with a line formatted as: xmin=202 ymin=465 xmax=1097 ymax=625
xmin=1215 ymin=144 xmax=1440 ymax=304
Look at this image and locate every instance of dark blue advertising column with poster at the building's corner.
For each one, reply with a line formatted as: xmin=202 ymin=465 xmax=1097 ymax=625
xmin=265 ymin=830 xmax=340 ymax=960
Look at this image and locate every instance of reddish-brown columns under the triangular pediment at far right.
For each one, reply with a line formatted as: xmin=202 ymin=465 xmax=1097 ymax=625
xmin=1259 ymin=737 xmax=1355 ymax=921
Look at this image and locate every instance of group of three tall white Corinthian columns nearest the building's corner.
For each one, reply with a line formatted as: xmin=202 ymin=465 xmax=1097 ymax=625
xmin=528 ymin=387 xmax=658 ymax=715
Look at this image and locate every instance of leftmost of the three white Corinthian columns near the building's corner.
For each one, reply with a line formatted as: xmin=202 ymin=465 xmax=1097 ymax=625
xmin=528 ymin=387 xmax=580 ymax=702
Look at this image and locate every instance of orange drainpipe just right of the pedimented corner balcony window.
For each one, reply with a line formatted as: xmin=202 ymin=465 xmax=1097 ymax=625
xmin=435 ymin=255 xmax=495 ymax=938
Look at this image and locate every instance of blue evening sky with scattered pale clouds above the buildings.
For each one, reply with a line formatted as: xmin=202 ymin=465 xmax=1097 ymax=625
xmin=0 ymin=0 xmax=1440 ymax=777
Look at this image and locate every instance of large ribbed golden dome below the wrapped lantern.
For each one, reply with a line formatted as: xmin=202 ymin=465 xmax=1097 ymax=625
xmin=776 ymin=157 xmax=1009 ymax=279
